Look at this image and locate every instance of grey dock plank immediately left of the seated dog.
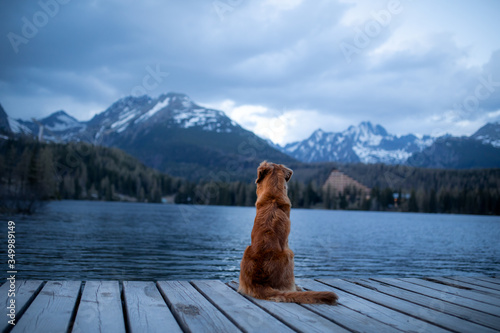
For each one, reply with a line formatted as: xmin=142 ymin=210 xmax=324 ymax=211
xmin=192 ymin=280 xmax=294 ymax=332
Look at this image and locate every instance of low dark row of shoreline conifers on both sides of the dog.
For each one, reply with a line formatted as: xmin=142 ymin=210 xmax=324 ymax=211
xmin=176 ymin=181 xmax=500 ymax=215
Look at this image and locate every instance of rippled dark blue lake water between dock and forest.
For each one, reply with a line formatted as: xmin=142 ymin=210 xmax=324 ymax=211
xmin=0 ymin=201 xmax=500 ymax=280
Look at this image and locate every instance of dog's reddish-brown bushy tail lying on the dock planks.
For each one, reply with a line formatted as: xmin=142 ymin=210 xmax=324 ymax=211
xmin=250 ymin=287 xmax=339 ymax=305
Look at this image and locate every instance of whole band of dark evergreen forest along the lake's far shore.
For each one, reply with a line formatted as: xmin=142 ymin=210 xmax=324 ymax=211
xmin=0 ymin=138 xmax=500 ymax=215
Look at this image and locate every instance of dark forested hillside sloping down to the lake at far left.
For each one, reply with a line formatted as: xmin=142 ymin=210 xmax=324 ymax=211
xmin=0 ymin=138 xmax=183 ymax=213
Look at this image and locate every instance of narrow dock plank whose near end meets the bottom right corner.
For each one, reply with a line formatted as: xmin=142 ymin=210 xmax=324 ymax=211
xmin=319 ymin=279 xmax=495 ymax=333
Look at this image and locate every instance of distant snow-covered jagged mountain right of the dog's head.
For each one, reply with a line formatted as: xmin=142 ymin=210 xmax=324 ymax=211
xmin=281 ymin=122 xmax=434 ymax=164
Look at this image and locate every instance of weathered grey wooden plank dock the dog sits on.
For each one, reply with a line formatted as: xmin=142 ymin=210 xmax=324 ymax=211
xmin=0 ymin=277 xmax=500 ymax=333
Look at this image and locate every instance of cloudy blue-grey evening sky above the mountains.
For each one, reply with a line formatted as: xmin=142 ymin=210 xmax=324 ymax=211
xmin=0 ymin=0 xmax=500 ymax=144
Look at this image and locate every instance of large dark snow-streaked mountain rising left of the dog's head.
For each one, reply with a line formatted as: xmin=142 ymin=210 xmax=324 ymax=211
xmin=5 ymin=93 xmax=295 ymax=181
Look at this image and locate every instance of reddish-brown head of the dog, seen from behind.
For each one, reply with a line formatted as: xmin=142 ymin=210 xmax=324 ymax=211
xmin=255 ymin=161 xmax=293 ymax=195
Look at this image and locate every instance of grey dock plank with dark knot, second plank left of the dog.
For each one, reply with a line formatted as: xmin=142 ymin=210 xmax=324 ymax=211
xmin=158 ymin=281 xmax=240 ymax=332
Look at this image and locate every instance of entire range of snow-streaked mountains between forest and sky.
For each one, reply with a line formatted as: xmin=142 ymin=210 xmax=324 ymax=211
xmin=0 ymin=92 xmax=500 ymax=170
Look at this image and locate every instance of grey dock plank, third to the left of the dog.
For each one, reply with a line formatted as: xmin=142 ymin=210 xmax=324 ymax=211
xmin=123 ymin=281 xmax=182 ymax=333
